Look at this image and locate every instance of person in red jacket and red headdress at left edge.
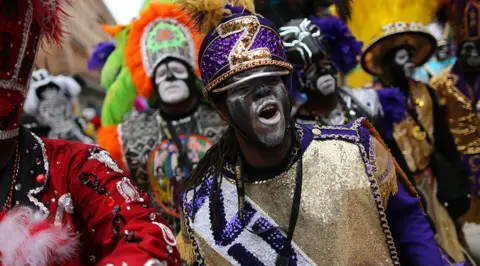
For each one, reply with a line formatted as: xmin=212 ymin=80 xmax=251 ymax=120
xmin=0 ymin=0 xmax=179 ymax=266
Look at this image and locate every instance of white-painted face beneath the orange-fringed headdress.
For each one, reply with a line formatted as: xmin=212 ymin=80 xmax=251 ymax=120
xmin=155 ymin=61 xmax=190 ymax=104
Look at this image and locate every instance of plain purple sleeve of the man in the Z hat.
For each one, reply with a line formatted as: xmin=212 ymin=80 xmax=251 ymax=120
xmin=386 ymin=181 xmax=446 ymax=265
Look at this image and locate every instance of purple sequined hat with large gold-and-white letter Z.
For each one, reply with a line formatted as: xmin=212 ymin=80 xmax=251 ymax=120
xmin=194 ymin=5 xmax=292 ymax=94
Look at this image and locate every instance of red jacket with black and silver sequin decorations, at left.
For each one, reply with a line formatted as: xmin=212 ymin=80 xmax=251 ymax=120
xmin=0 ymin=130 xmax=180 ymax=266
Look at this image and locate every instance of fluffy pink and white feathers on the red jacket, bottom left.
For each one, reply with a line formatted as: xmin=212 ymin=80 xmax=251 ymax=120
xmin=0 ymin=207 xmax=78 ymax=266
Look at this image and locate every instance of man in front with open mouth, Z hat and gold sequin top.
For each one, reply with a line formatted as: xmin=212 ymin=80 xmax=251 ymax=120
xmin=178 ymin=0 xmax=443 ymax=265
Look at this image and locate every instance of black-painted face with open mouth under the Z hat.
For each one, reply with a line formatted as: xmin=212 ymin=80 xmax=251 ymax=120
xmin=226 ymin=71 xmax=291 ymax=148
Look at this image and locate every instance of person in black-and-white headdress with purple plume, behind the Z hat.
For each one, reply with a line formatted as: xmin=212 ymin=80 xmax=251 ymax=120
xmin=280 ymin=16 xmax=405 ymax=129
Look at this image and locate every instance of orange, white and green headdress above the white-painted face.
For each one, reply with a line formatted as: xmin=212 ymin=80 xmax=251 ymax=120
xmin=98 ymin=0 xmax=203 ymax=126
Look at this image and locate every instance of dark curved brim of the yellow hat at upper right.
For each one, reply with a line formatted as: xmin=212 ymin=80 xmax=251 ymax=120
xmin=360 ymin=30 xmax=437 ymax=76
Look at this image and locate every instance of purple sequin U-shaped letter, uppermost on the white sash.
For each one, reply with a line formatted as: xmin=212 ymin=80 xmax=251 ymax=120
xmin=210 ymin=184 xmax=257 ymax=246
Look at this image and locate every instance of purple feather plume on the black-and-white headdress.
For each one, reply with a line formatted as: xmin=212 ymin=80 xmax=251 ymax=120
xmin=310 ymin=16 xmax=363 ymax=74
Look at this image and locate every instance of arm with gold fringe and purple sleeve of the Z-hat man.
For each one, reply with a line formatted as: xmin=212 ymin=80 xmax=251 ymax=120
xmin=372 ymin=132 xmax=445 ymax=265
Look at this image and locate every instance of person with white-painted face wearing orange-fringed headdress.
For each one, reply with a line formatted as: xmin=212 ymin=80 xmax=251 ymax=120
xmin=98 ymin=2 xmax=226 ymax=234
